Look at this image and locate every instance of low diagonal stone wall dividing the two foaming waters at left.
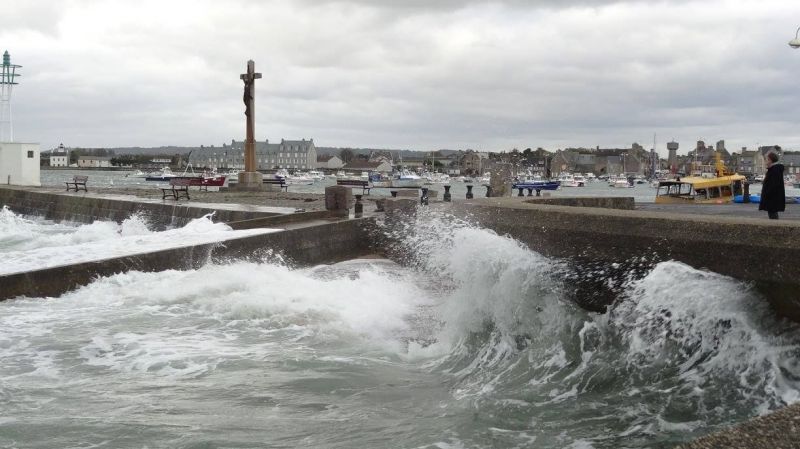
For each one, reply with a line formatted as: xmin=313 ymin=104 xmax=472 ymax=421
xmin=0 ymin=218 xmax=372 ymax=300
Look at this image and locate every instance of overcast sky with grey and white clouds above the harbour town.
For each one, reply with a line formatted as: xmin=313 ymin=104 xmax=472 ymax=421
xmin=0 ymin=0 xmax=800 ymax=154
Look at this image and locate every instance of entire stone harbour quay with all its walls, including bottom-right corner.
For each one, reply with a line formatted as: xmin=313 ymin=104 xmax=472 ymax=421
xmin=0 ymin=187 xmax=800 ymax=448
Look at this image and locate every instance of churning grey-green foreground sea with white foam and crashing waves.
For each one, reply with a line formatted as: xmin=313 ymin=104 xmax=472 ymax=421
xmin=0 ymin=208 xmax=800 ymax=448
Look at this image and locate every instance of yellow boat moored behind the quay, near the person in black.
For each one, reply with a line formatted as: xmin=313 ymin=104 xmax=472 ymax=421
xmin=656 ymin=153 xmax=746 ymax=204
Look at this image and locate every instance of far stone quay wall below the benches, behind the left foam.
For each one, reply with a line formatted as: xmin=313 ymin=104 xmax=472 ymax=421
xmin=0 ymin=187 xmax=288 ymax=230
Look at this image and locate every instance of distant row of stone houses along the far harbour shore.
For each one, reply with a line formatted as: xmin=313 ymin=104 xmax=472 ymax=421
xmin=45 ymin=139 xmax=800 ymax=176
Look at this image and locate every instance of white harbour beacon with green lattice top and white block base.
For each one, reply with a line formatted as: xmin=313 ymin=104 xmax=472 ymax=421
xmin=0 ymin=51 xmax=41 ymax=186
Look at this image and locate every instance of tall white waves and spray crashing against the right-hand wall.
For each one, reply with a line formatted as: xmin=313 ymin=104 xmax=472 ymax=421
xmin=380 ymin=209 xmax=800 ymax=447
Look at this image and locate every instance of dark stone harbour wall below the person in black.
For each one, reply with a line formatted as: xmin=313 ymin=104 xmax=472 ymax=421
xmin=446 ymin=198 xmax=800 ymax=316
